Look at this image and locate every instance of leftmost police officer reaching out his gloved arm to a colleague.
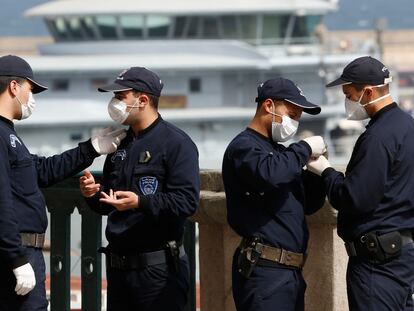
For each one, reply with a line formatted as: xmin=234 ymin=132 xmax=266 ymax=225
xmin=0 ymin=55 xmax=125 ymax=311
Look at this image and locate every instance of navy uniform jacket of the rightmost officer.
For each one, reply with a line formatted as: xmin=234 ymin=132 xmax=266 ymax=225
xmin=322 ymin=103 xmax=414 ymax=242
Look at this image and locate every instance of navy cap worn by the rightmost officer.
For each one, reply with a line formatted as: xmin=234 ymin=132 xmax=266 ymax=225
xmin=326 ymin=56 xmax=392 ymax=87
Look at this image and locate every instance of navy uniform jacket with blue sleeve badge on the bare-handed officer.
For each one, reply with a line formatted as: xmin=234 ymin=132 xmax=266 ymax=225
xmin=87 ymin=116 xmax=200 ymax=254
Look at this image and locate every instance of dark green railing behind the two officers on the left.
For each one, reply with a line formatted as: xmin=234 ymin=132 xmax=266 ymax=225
xmin=43 ymin=173 xmax=196 ymax=311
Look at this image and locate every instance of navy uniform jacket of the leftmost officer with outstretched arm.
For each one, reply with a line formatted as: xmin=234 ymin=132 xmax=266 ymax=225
xmin=0 ymin=116 xmax=99 ymax=268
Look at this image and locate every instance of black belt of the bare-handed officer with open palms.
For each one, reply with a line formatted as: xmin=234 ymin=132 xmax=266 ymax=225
xmin=102 ymin=245 xmax=185 ymax=270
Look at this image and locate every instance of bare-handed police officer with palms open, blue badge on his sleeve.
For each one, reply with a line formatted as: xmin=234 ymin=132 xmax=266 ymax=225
xmin=80 ymin=67 xmax=199 ymax=311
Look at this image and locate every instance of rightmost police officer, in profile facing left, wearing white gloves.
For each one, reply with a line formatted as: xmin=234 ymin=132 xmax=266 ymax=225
xmin=308 ymin=56 xmax=414 ymax=311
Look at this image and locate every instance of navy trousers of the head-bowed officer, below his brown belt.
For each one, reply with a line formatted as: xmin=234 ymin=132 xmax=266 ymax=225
xmin=232 ymin=250 xmax=306 ymax=311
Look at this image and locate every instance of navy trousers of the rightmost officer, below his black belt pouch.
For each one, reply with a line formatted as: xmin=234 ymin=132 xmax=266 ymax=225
xmin=346 ymin=244 xmax=414 ymax=311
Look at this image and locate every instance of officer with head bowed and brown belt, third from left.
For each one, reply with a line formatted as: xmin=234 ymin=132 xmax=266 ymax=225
xmin=223 ymin=78 xmax=326 ymax=311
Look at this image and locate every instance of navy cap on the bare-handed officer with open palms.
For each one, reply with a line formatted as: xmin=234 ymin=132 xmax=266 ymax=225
xmin=98 ymin=67 xmax=164 ymax=97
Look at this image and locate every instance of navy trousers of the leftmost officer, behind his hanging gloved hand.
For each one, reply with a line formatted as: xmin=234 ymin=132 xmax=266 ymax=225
xmin=0 ymin=247 xmax=49 ymax=311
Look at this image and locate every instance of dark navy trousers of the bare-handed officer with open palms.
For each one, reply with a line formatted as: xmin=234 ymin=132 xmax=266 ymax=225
xmin=106 ymin=256 xmax=190 ymax=311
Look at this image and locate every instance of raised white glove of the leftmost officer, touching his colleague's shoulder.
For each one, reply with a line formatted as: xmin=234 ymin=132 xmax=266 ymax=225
xmin=92 ymin=127 xmax=126 ymax=154
